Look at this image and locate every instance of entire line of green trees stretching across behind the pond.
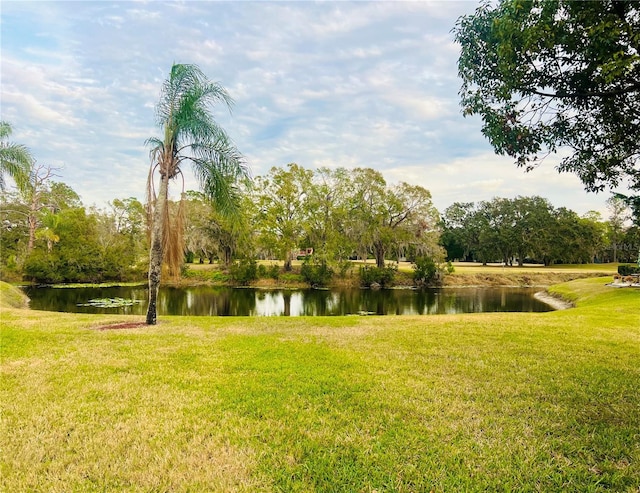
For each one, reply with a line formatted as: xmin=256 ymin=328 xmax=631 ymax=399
xmin=0 ymin=163 xmax=640 ymax=282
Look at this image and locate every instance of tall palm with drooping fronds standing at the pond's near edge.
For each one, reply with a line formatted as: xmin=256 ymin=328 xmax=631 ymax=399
xmin=147 ymin=64 xmax=248 ymax=325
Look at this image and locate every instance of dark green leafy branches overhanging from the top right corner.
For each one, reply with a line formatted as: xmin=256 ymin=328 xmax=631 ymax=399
xmin=455 ymin=0 xmax=640 ymax=191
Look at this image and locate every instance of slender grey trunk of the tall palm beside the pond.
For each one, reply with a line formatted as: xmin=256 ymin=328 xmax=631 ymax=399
xmin=147 ymin=174 xmax=169 ymax=325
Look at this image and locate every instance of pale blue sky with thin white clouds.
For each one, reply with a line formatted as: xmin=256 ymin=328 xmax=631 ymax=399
xmin=0 ymin=0 xmax=610 ymax=218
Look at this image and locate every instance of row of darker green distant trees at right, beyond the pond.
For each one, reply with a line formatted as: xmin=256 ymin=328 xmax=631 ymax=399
xmin=440 ymin=197 xmax=640 ymax=265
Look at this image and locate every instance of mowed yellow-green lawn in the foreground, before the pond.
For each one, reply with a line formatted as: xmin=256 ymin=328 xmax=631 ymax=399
xmin=0 ymin=278 xmax=640 ymax=492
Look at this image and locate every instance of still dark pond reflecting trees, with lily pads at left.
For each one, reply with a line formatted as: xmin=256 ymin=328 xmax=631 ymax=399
xmin=23 ymin=286 xmax=552 ymax=316
